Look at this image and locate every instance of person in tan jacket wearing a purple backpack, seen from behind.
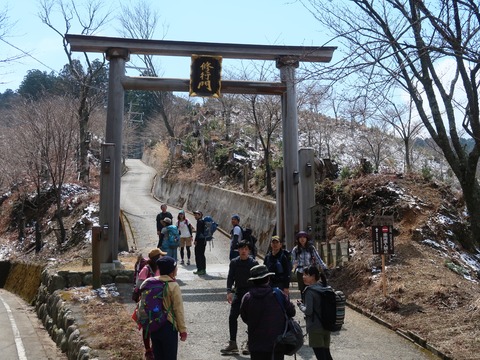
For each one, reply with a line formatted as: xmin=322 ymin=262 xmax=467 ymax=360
xmin=136 ymin=256 xmax=187 ymax=360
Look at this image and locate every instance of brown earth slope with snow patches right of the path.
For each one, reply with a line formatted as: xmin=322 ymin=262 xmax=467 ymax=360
xmin=317 ymin=175 xmax=480 ymax=359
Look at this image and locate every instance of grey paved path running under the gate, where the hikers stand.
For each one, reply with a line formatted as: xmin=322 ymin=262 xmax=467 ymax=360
xmin=119 ymin=160 xmax=437 ymax=360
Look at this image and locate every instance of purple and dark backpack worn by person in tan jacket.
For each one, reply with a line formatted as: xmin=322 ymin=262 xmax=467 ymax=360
xmin=135 ymin=278 xmax=172 ymax=336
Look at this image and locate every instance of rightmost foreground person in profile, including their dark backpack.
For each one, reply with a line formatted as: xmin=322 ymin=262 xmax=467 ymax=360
xmin=297 ymin=265 xmax=337 ymax=360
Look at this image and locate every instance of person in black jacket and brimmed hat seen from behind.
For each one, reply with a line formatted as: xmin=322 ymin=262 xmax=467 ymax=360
xmin=240 ymin=265 xmax=295 ymax=360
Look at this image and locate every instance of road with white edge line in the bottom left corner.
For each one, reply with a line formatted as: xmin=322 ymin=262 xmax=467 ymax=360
xmin=0 ymin=289 xmax=67 ymax=360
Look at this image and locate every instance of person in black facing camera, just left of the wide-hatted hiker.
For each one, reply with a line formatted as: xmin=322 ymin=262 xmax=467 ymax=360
xmin=263 ymin=235 xmax=292 ymax=295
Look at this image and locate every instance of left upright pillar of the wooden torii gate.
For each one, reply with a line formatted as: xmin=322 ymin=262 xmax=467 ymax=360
xmin=104 ymin=48 xmax=129 ymax=262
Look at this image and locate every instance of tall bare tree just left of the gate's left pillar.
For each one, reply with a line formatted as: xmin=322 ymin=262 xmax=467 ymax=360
xmin=38 ymin=0 xmax=109 ymax=184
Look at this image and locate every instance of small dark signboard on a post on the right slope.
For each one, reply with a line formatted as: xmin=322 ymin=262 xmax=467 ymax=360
xmin=372 ymin=216 xmax=394 ymax=296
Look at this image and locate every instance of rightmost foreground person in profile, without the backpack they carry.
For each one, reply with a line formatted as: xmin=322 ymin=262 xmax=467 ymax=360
xmin=297 ymin=266 xmax=332 ymax=360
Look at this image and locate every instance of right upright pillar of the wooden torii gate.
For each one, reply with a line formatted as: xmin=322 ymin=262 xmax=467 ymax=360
xmin=277 ymin=56 xmax=299 ymax=249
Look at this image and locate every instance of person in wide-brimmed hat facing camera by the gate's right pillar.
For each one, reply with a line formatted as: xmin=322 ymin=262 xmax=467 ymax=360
xmin=292 ymin=231 xmax=327 ymax=300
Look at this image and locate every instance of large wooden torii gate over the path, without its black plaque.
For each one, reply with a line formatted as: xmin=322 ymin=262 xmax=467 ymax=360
xmin=65 ymin=34 xmax=336 ymax=264
